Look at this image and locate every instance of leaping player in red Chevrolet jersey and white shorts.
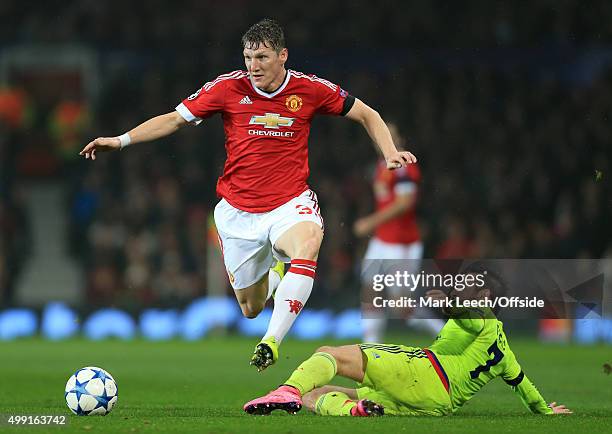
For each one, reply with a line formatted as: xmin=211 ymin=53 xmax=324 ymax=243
xmin=80 ymin=19 xmax=416 ymax=371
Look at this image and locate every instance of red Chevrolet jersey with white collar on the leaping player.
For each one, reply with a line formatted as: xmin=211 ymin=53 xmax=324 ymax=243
xmin=176 ymin=70 xmax=352 ymax=213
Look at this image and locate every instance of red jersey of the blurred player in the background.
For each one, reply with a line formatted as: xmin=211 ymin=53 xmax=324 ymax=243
xmin=374 ymin=160 xmax=421 ymax=244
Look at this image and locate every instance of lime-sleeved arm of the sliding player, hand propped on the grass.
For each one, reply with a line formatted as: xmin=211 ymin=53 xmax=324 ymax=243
xmin=502 ymin=352 xmax=571 ymax=414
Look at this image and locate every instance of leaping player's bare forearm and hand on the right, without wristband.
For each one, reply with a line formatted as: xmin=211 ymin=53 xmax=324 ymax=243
xmin=346 ymin=98 xmax=417 ymax=169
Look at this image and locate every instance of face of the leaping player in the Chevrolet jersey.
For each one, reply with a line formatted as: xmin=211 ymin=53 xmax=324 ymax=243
xmin=243 ymin=44 xmax=288 ymax=92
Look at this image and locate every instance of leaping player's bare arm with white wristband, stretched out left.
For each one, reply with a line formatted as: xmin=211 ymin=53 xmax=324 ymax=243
xmin=79 ymin=111 xmax=187 ymax=160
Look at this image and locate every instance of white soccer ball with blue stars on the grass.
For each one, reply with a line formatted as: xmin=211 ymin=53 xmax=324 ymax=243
xmin=64 ymin=366 xmax=117 ymax=416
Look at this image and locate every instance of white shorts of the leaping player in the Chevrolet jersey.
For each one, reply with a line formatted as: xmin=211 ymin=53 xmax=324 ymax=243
xmin=215 ymin=190 xmax=323 ymax=289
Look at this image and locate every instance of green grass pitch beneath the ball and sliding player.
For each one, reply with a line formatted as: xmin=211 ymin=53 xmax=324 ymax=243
xmin=0 ymin=335 xmax=612 ymax=434
